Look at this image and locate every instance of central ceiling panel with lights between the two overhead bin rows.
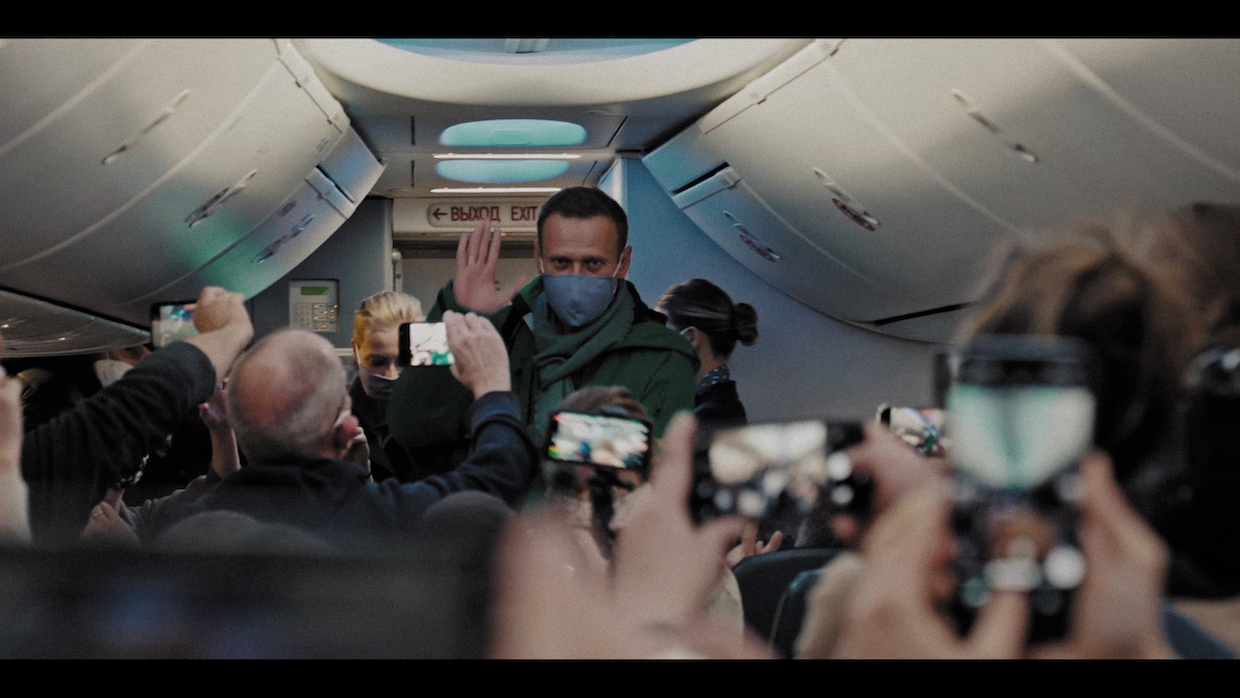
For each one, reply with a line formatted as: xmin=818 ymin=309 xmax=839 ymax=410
xmin=295 ymin=38 xmax=810 ymax=200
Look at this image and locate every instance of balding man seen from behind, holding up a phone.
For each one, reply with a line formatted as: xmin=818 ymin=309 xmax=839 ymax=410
xmin=162 ymin=312 xmax=537 ymax=549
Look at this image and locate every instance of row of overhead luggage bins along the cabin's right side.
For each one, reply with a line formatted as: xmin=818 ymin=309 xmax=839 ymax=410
xmin=644 ymin=40 xmax=1240 ymax=341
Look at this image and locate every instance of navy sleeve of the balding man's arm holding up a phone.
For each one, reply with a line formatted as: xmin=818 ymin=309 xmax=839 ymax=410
xmin=384 ymin=392 xmax=538 ymax=519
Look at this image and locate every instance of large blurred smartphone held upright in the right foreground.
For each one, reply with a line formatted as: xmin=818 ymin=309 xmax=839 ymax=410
xmin=947 ymin=335 xmax=1095 ymax=643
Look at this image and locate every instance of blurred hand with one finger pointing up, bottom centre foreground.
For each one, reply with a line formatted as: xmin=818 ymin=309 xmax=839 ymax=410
xmin=491 ymin=415 xmax=770 ymax=658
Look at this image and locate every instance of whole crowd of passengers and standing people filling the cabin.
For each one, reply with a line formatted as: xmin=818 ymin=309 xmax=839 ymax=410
xmin=0 ymin=187 xmax=1240 ymax=658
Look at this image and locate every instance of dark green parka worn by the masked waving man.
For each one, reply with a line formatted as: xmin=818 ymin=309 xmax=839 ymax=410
xmin=388 ymin=276 xmax=701 ymax=463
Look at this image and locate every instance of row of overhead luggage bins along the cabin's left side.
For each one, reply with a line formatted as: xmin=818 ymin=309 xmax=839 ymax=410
xmin=0 ymin=40 xmax=383 ymax=353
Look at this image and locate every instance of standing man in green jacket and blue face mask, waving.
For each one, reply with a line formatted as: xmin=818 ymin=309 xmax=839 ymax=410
xmin=388 ymin=187 xmax=699 ymax=476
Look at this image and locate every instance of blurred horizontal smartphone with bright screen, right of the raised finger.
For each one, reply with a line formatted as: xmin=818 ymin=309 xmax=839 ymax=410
xmin=689 ymin=419 xmax=872 ymax=522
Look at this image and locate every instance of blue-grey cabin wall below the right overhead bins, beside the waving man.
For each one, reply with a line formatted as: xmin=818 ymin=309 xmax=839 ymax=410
xmin=610 ymin=160 xmax=937 ymax=422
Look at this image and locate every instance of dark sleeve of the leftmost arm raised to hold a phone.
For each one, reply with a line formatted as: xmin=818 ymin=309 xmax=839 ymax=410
xmin=21 ymin=342 xmax=216 ymax=542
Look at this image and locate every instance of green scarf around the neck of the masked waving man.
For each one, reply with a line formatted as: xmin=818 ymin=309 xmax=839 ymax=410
xmin=531 ymin=287 xmax=634 ymax=445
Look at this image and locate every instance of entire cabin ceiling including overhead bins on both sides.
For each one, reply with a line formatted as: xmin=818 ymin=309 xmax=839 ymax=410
xmin=0 ymin=38 xmax=1240 ymax=356
